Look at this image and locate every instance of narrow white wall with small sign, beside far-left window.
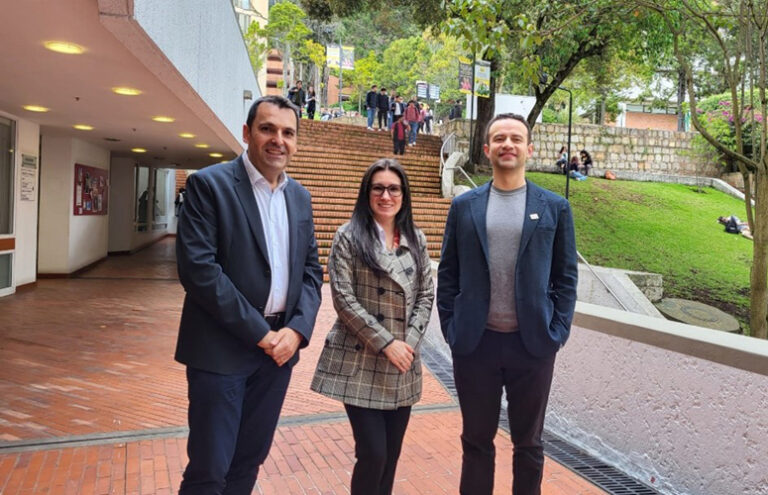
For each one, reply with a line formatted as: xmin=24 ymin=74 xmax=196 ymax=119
xmin=12 ymin=117 xmax=40 ymax=286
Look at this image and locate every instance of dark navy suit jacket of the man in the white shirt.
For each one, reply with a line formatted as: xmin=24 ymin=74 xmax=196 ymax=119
xmin=176 ymin=157 xmax=323 ymax=374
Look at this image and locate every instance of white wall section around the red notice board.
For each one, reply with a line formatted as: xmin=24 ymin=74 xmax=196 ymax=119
xmin=38 ymin=134 xmax=112 ymax=274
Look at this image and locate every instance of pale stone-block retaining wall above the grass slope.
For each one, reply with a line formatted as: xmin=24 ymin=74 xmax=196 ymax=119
xmin=440 ymin=120 xmax=720 ymax=177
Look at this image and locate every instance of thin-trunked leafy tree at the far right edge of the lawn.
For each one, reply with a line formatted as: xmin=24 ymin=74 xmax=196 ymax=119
xmin=643 ymin=0 xmax=768 ymax=339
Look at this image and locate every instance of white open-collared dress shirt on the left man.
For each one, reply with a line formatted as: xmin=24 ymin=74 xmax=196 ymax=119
xmin=242 ymin=152 xmax=290 ymax=315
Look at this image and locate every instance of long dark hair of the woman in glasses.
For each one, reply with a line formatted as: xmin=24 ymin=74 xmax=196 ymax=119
xmin=349 ymin=158 xmax=423 ymax=275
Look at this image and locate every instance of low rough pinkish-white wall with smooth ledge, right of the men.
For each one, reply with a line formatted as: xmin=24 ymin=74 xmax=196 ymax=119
xmin=546 ymin=303 xmax=768 ymax=495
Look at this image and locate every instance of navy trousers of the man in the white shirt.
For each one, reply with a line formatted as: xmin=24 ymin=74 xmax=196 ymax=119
xmin=179 ymin=355 xmax=291 ymax=495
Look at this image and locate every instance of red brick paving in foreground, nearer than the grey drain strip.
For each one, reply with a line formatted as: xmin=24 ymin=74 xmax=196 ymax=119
xmin=0 ymin=411 xmax=604 ymax=495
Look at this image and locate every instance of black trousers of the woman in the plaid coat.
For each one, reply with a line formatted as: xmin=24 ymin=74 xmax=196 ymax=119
xmin=344 ymin=404 xmax=411 ymax=495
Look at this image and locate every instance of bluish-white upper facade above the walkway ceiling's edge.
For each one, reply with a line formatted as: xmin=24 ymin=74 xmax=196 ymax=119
xmin=133 ymin=0 xmax=260 ymax=142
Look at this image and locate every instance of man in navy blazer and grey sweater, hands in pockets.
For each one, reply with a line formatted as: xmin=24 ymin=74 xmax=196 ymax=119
xmin=437 ymin=114 xmax=578 ymax=495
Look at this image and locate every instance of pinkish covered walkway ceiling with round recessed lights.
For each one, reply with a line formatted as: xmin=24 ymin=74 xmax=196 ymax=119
xmin=0 ymin=0 xmax=240 ymax=168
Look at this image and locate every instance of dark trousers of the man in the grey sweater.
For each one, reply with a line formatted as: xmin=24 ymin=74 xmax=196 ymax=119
xmin=453 ymin=330 xmax=555 ymax=495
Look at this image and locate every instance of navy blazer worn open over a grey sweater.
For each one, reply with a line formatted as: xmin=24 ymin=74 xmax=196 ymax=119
xmin=437 ymin=181 xmax=578 ymax=357
